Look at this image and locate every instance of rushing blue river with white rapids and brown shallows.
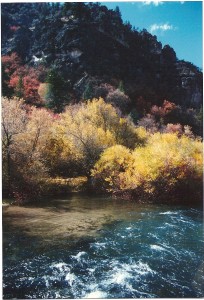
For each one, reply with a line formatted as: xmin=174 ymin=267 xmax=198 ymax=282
xmin=3 ymin=195 xmax=204 ymax=299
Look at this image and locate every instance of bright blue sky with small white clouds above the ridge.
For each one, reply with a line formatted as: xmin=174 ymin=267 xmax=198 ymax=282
xmin=101 ymin=0 xmax=203 ymax=68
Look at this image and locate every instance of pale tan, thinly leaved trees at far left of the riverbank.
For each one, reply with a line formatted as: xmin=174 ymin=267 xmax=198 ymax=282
xmin=2 ymin=98 xmax=53 ymax=201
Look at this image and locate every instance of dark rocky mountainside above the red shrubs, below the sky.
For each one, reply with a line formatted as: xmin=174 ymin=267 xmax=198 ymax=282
xmin=2 ymin=3 xmax=202 ymax=108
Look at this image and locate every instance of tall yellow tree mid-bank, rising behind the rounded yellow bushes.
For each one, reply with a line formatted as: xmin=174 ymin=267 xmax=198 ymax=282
xmin=61 ymin=98 xmax=138 ymax=174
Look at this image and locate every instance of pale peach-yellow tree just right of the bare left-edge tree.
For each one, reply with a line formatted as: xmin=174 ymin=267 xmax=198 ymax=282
xmin=15 ymin=107 xmax=54 ymax=196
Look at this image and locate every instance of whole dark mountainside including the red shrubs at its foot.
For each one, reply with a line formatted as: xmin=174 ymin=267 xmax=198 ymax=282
xmin=1 ymin=2 xmax=202 ymax=135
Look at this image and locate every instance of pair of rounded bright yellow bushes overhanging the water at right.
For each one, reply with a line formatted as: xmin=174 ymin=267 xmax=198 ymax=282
xmin=92 ymin=133 xmax=203 ymax=203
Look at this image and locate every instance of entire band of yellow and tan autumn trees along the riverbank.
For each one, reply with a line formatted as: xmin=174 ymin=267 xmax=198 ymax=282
xmin=2 ymin=97 xmax=203 ymax=203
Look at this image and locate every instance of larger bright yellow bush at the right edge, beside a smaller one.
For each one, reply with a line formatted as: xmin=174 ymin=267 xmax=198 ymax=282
xmin=130 ymin=133 xmax=202 ymax=202
